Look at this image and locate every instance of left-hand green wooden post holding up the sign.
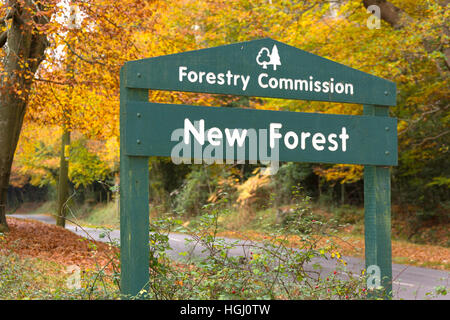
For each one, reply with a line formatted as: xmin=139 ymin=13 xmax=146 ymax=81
xmin=120 ymin=66 xmax=150 ymax=296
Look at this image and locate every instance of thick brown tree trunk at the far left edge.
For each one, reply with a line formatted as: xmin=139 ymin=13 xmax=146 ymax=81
xmin=0 ymin=0 xmax=48 ymax=231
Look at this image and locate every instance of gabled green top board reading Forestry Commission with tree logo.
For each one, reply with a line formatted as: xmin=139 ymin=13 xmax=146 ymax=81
xmin=124 ymin=38 xmax=396 ymax=106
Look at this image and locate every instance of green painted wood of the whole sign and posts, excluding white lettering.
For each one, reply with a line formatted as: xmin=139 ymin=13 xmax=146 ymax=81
xmin=120 ymin=39 xmax=397 ymax=296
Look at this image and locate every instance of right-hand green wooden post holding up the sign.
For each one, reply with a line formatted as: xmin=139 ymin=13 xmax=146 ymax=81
xmin=363 ymin=105 xmax=395 ymax=296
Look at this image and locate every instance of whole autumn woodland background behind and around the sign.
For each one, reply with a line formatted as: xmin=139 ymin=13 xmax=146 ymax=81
xmin=0 ymin=0 xmax=450 ymax=246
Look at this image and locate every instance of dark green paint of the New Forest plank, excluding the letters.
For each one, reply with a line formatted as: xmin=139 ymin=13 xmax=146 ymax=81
xmin=125 ymin=102 xmax=397 ymax=165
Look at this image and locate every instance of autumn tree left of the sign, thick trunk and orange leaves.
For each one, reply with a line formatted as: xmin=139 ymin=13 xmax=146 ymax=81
xmin=0 ymin=0 xmax=163 ymax=230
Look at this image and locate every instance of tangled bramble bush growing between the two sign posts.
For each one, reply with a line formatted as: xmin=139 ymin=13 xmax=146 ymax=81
xmin=136 ymin=194 xmax=367 ymax=299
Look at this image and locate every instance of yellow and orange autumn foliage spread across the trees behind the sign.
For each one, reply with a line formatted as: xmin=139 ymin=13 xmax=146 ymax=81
xmin=10 ymin=0 xmax=450 ymax=198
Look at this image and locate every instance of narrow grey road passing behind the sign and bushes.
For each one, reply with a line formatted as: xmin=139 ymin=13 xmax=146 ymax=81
xmin=8 ymin=214 xmax=450 ymax=300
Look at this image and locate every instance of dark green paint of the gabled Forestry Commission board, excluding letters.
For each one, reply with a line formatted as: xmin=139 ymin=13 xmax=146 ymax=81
xmin=126 ymin=38 xmax=396 ymax=106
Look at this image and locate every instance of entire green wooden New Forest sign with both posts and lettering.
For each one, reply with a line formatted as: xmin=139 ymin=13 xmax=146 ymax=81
xmin=120 ymin=38 xmax=398 ymax=295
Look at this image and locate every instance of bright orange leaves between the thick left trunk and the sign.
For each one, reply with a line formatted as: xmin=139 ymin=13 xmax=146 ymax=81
xmin=27 ymin=0 xmax=169 ymax=139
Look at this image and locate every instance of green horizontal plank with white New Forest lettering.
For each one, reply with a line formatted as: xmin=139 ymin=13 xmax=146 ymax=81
xmin=122 ymin=102 xmax=397 ymax=166
